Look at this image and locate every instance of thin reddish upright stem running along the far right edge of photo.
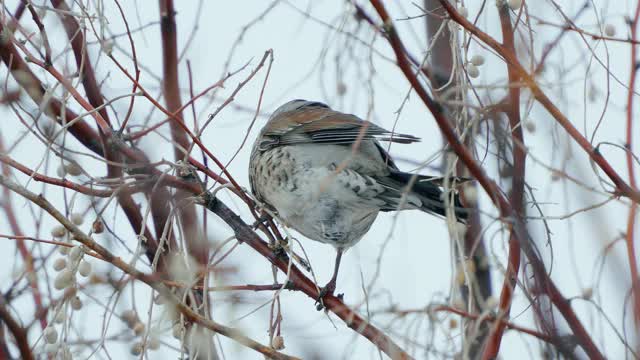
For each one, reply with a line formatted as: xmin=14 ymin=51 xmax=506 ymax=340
xmin=625 ymin=2 xmax=640 ymax=329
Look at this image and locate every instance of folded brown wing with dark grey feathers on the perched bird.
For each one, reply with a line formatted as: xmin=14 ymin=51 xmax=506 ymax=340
xmin=261 ymin=106 xmax=420 ymax=150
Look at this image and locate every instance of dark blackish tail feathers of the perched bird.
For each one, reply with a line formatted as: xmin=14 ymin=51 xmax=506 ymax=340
xmin=380 ymin=171 xmax=469 ymax=223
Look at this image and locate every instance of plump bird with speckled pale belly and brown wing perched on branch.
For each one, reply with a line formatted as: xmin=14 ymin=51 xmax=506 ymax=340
xmin=249 ymin=100 xmax=467 ymax=297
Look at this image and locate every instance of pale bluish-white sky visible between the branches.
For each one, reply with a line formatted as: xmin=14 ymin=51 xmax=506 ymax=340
xmin=0 ymin=0 xmax=637 ymax=359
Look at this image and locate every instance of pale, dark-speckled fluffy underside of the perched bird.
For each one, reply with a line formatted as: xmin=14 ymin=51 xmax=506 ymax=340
xmin=250 ymin=146 xmax=381 ymax=248
